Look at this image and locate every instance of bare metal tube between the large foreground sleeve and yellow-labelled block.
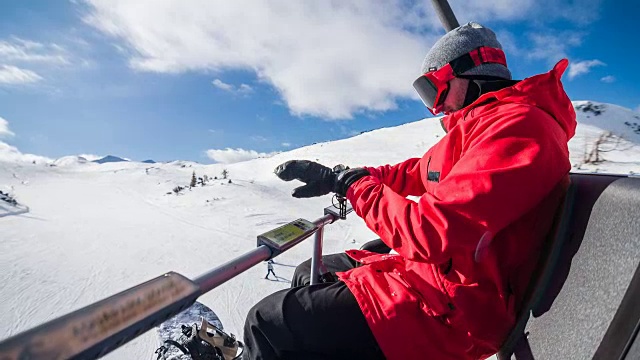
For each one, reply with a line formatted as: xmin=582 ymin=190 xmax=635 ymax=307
xmin=193 ymin=245 xmax=271 ymax=295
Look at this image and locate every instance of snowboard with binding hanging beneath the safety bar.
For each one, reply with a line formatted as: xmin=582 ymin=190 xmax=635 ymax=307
xmin=154 ymin=302 xmax=242 ymax=360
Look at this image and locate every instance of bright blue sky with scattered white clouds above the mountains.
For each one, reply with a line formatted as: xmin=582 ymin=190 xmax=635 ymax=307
xmin=0 ymin=0 xmax=640 ymax=163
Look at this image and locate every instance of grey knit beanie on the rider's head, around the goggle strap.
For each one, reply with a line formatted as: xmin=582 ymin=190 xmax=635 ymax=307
xmin=422 ymin=22 xmax=511 ymax=80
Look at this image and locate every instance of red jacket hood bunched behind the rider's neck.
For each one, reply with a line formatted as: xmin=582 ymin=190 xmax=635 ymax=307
xmin=441 ymin=59 xmax=577 ymax=140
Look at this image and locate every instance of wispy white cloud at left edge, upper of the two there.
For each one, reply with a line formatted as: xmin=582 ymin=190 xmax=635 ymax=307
xmin=0 ymin=37 xmax=70 ymax=65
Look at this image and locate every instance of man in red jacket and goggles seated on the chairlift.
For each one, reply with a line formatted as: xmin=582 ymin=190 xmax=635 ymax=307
xmin=244 ymin=23 xmax=576 ymax=360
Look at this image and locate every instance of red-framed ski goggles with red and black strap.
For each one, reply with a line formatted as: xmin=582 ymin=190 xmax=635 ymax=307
xmin=413 ymin=46 xmax=507 ymax=115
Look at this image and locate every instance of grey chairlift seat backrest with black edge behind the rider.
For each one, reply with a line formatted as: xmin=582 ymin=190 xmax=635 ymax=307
xmin=525 ymin=174 xmax=640 ymax=360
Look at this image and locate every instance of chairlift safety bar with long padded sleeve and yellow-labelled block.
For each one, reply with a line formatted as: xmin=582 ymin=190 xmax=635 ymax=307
xmin=0 ymin=202 xmax=350 ymax=360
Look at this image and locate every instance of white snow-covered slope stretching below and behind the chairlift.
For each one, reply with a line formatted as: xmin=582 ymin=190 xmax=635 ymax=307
xmin=0 ymin=102 xmax=640 ymax=359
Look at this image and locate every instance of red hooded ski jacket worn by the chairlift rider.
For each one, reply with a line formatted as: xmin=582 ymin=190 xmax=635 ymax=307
xmin=338 ymin=59 xmax=576 ymax=360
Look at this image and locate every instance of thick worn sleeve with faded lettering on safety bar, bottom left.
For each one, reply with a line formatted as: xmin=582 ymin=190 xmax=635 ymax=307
xmin=0 ymin=273 xmax=198 ymax=360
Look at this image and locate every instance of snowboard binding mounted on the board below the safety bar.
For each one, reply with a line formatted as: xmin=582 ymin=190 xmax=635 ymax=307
xmin=156 ymin=317 xmax=244 ymax=360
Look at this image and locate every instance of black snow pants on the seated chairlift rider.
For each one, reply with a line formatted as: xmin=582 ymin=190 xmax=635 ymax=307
xmin=243 ymin=254 xmax=384 ymax=360
